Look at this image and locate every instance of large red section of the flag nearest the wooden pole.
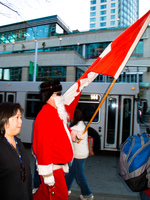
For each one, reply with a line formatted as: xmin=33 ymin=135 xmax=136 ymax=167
xmin=77 ymin=10 xmax=150 ymax=79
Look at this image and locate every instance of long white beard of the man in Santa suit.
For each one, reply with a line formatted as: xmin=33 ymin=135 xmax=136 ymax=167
xmin=54 ymin=96 xmax=68 ymax=123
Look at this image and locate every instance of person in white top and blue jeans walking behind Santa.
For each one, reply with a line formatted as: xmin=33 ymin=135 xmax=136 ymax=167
xmin=65 ymin=109 xmax=94 ymax=200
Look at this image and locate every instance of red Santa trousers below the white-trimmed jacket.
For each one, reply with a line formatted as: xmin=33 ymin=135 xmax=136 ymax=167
xmin=33 ymin=169 xmax=68 ymax=200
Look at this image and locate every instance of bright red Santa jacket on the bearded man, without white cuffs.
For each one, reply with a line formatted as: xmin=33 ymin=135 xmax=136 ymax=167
xmin=33 ymin=104 xmax=73 ymax=170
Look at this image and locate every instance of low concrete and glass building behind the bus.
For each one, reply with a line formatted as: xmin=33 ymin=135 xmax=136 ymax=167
xmin=0 ymin=16 xmax=150 ymax=111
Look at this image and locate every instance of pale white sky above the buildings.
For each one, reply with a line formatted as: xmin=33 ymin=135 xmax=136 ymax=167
xmin=0 ymin=0 xmax=150 ymax=31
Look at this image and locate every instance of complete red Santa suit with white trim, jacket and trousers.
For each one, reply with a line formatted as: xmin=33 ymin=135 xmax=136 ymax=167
xmin=33 ymin=104 xmax=73 ymax=200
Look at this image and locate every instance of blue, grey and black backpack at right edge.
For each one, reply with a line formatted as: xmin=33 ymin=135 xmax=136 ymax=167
xmin=119 ymin=133 xmax=150 ymax=192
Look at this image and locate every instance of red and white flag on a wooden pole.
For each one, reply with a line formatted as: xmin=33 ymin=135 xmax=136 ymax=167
xmin=64 ymin=10 xmax=150 ymax=119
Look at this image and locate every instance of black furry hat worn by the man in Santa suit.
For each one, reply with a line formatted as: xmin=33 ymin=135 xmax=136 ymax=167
xmin=40 ymin=79 xmax=62 ymax=103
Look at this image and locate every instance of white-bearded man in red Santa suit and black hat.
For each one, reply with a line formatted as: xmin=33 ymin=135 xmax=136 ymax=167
xmin=33 ymin=79 xmax=76 ymax=200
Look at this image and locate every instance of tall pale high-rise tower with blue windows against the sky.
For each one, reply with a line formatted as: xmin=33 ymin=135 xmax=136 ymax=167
xmin=90 ymin=0 xmax=139 ymax=30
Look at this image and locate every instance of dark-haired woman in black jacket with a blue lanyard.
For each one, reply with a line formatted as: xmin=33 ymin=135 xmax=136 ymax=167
xmin=0 ymin=102 xmax=32 ymax=200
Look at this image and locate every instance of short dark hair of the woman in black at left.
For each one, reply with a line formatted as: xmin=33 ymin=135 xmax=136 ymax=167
xmin=0 ymin=102 xmax=23 ymax=135
